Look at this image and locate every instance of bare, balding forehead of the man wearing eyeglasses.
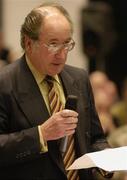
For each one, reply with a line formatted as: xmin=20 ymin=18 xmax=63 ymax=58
xmin=38 ymin=7 xmax=72 ymax=38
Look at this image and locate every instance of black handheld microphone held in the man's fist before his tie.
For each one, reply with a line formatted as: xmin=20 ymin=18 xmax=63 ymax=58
xmin=60 ymin=95 xmax=78 ymax=153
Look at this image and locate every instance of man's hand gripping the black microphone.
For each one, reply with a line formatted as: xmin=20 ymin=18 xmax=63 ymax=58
xmin=41 ymin=109 xmax=78 ymax=141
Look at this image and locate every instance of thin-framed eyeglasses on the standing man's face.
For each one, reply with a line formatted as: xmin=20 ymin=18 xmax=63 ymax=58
xmin=43 ymin=39 xmax=75 ymax=53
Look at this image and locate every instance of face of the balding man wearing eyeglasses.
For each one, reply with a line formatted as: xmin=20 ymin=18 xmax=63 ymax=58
xmin=28 ymin=13 xmax=72 ymax=75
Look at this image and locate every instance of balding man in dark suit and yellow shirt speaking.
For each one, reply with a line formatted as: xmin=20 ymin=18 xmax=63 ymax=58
xmin=0 ymin=3 xmax=112 ymax=180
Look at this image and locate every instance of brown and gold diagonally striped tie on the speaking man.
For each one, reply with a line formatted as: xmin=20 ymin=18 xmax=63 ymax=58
xmin=45 ymin=76 xmax=79 ymax=180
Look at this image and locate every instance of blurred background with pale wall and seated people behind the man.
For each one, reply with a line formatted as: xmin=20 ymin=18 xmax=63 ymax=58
xmin=0 ymin=0 xmax=127 ymax=180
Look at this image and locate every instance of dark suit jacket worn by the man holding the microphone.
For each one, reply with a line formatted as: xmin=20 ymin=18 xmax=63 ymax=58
xmin=0 ymin=56 xmax=107 ymax=180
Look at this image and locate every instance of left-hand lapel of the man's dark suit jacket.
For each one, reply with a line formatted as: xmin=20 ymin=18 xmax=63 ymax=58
xmin=13 ymin=58 xmax=49 ymax=126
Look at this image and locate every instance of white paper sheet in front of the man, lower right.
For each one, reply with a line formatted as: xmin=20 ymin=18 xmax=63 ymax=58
xmin=68 ymin=146 xmax=127 ymax=171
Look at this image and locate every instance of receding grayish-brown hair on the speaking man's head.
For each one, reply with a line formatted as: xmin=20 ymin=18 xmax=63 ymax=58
xmin=20 ymin=2 xmax=73 ymax=49
